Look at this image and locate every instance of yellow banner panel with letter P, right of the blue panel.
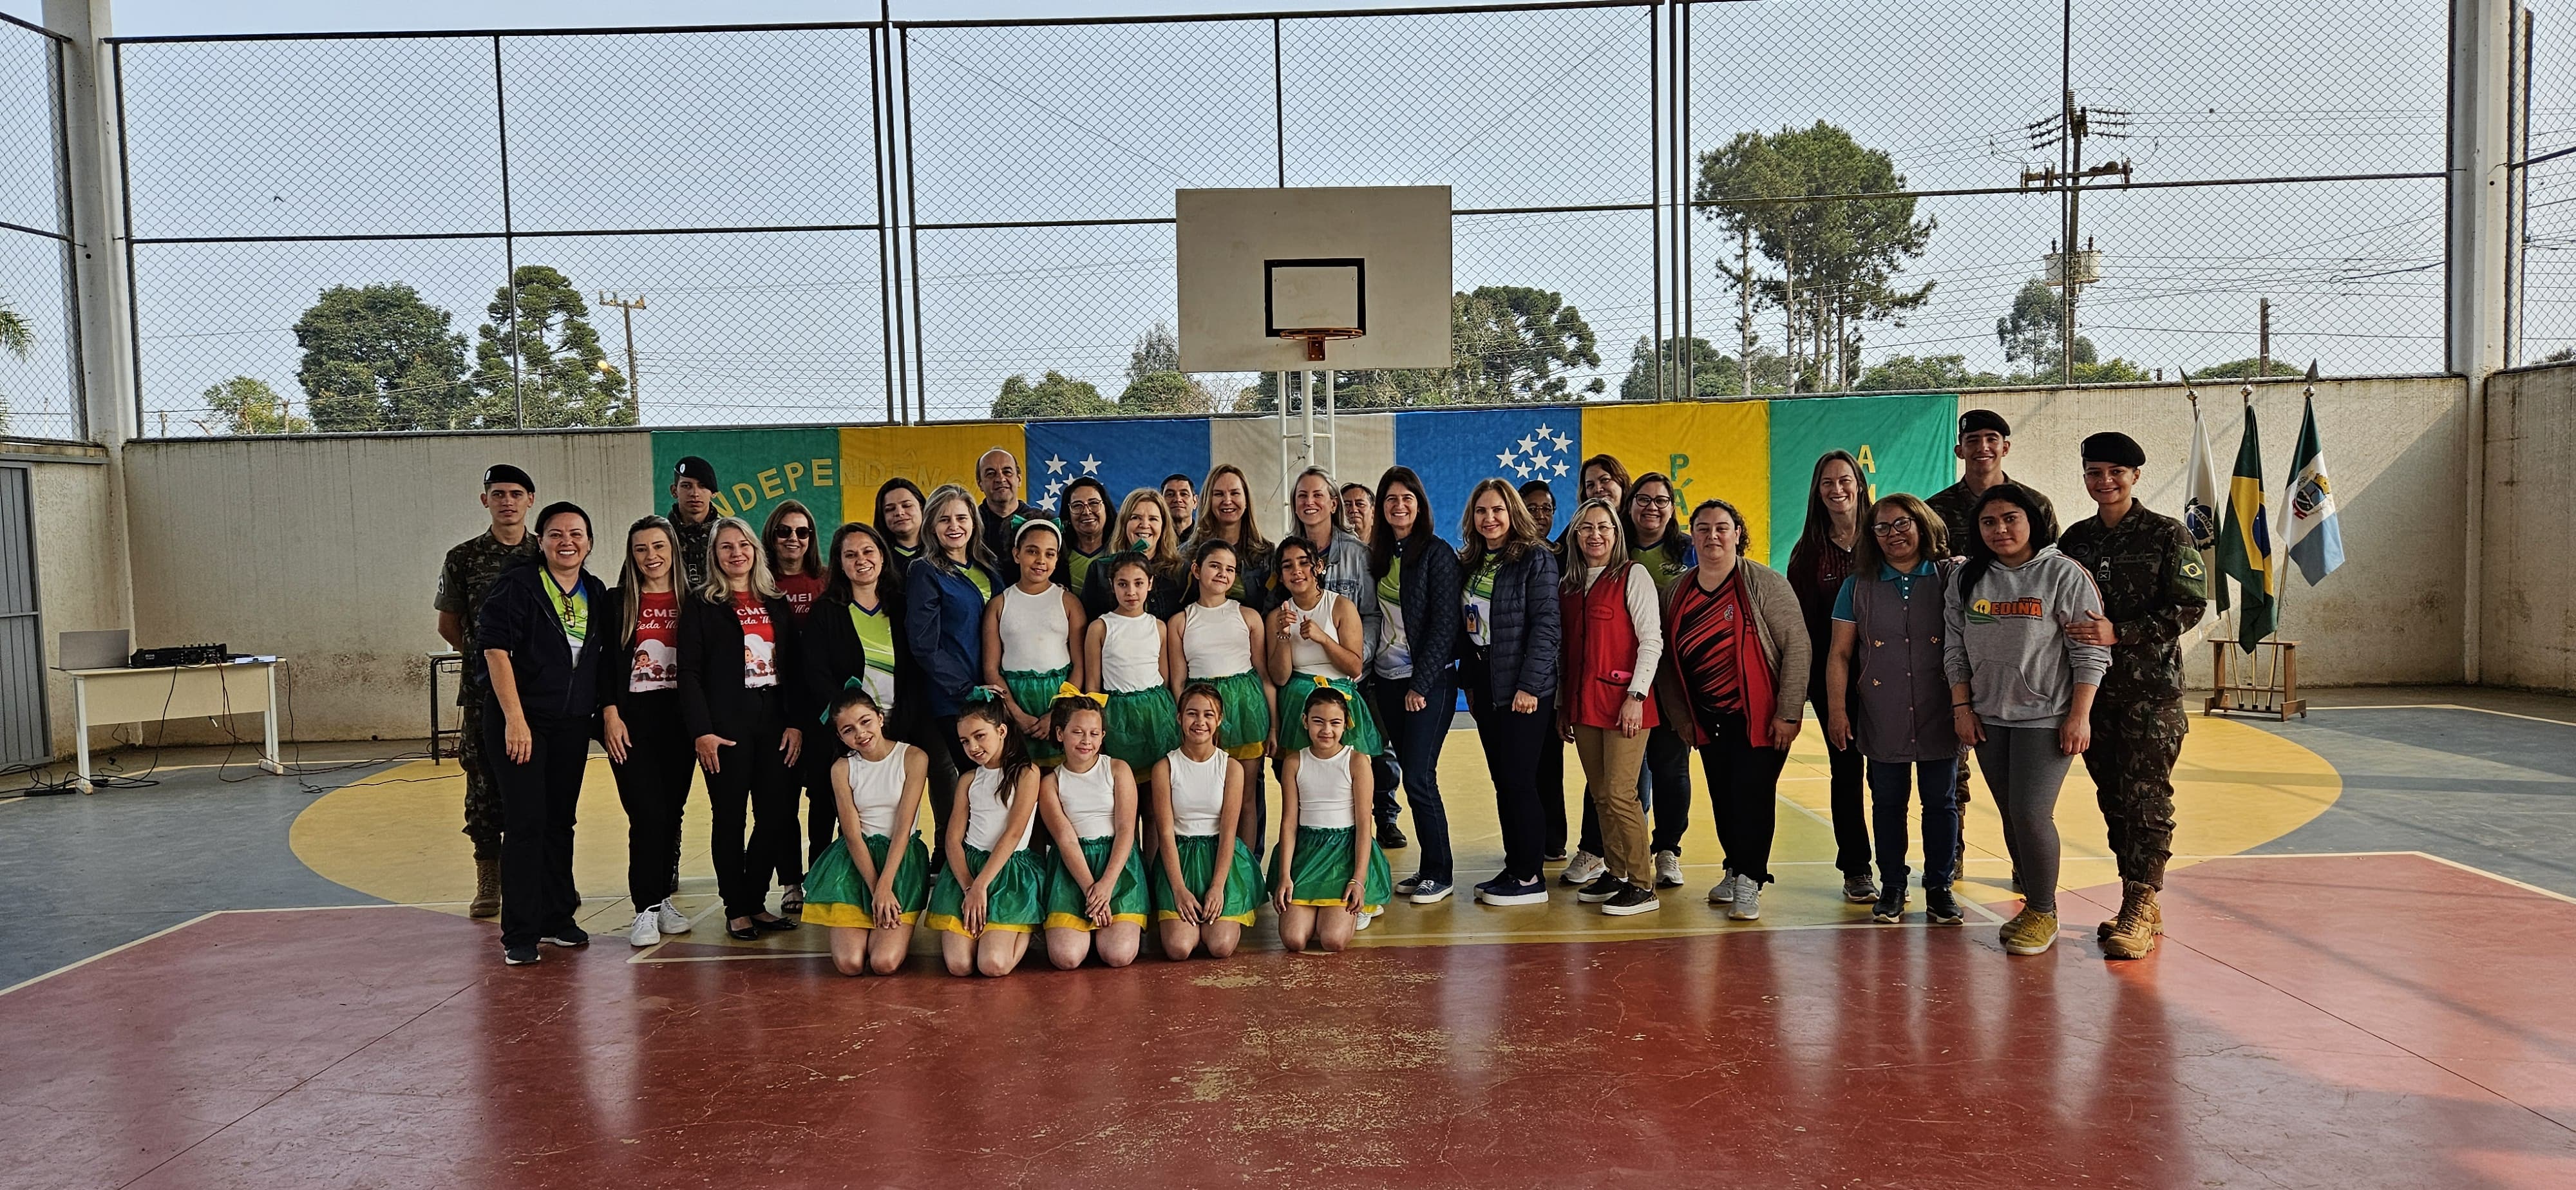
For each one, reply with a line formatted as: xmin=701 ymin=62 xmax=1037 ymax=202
xmin=1569 ymin=402 xmax=1772 ymax=559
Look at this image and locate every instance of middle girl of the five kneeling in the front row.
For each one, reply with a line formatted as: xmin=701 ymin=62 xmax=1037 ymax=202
xmin=1038 ymin=685 xmax=1146 ymax=971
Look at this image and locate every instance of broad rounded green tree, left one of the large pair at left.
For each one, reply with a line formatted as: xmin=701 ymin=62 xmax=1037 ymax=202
xmin=294 ymin=281 xmax=474 ymax=430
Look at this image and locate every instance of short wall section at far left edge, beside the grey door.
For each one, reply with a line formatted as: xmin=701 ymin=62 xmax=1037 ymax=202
xmin=0 ymin=443 xmax=126 ymax=755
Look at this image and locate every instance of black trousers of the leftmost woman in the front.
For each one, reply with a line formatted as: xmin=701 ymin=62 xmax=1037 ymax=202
xmin=482 ymin=706 xmax=590 ymax=945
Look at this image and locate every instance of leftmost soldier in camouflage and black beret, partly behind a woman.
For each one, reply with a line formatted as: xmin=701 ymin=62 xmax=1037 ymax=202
xmin=430 ymin=464 xmax=536 ymax=917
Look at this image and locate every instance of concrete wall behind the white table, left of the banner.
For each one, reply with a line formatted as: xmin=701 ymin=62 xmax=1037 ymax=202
xmin=124 ymin=430 xmax=654 ymax=742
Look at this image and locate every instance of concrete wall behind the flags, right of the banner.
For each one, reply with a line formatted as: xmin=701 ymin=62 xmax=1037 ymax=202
xmin=1960 ymin=376 xmax=2468 ymax=685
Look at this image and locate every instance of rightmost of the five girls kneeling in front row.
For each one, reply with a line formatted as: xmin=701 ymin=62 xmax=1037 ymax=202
xmin=1270 ymin=685 xmax=1394 ymax=953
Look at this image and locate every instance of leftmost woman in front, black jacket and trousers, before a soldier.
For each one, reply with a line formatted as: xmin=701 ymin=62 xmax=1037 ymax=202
xmin=474 ymin=502 xmax=616 ymax=966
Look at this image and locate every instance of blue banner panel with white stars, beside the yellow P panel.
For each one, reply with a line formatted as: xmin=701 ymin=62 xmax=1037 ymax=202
xmin=1396 ymin=404 xmax=1584 ymax=546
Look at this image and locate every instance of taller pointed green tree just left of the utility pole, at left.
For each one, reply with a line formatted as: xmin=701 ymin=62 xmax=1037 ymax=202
xmin=474 ymin=265 xmax=636 ymax=430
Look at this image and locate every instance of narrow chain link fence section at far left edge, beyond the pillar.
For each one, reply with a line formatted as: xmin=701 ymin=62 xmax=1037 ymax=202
xmin=0 ymin=15 xmax=88 ymax=440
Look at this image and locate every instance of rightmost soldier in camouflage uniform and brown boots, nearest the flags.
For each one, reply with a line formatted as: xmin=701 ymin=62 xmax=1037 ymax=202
xmin=2058 ymin=433 xmax=2210 ymax=958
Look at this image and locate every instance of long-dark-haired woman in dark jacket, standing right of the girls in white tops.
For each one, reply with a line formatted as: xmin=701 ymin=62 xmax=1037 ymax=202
xmin=1365 ymin=466 xmax=1463 ymax=904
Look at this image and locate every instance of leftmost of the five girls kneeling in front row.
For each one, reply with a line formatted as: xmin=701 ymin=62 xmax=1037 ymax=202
xmin=804 ymin=685 xmax=930 ymax=976
